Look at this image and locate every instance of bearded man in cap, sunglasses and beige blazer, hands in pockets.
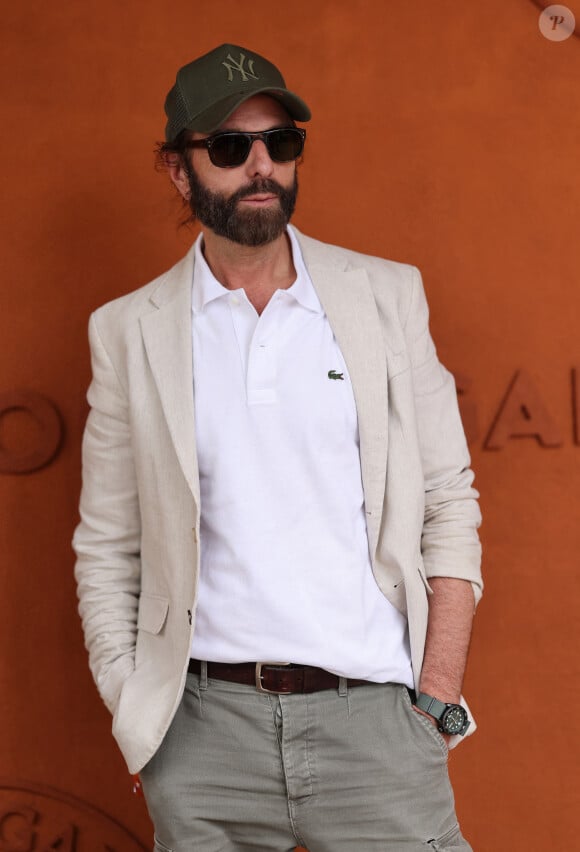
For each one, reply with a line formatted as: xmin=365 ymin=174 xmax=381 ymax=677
xmin=74 ymin=45 xmax=481 ymax=852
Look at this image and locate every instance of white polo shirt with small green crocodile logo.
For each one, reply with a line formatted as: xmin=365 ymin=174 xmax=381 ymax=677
xmin=191 ymin=228 xmax=413 ymax=686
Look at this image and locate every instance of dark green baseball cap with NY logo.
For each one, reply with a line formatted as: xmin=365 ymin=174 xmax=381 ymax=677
xmin=165 ymin=44 xmax=311 ymax=142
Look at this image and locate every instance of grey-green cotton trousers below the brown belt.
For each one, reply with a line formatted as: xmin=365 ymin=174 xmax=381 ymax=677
xmin=141 ymin=672 xmax=471 ymax=852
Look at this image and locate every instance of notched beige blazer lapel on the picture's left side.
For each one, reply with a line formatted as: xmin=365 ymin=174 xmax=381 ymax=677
xmin=141 ymin=253 xmax=199 ymax=505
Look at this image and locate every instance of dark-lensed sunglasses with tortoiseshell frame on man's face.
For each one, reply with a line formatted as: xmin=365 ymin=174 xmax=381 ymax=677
xmin=186 ymin=127 xmax=306 ymax=169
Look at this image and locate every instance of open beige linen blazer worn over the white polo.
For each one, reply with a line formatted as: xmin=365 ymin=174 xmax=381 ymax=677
xmin=73 ymin=232 xmax=482 ymax=772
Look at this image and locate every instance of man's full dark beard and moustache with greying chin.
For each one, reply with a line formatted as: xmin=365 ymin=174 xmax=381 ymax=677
xmin=188 ymin=166 xmax=298 ymax=246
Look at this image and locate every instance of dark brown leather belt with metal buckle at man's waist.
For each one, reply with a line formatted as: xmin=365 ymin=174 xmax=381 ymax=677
xmin=187 ymin=659 xmax=371 ymax=695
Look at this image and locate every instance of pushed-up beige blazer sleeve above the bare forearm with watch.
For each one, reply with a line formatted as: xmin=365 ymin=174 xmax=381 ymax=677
xmin=405 ymin=268 xmax=483 ymax=603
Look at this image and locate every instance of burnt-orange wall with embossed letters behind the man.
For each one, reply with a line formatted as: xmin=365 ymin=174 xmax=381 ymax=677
xmin=0 ymin=0 xmax=580 ymax=852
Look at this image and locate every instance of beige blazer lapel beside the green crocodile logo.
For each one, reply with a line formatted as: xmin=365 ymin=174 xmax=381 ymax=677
xmin=298 ymin=234 xmax=388 ymax=560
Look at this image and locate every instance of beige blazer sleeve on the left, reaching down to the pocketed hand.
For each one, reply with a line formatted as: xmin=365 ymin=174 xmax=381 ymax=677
xmin=73 ymin=313 xmax=141 ymax=712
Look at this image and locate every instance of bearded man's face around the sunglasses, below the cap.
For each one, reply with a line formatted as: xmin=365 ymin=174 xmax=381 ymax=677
xmin=169 ymin=95 xmax=298 ymax=246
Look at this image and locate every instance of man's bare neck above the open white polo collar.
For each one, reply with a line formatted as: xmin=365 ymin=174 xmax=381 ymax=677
xmin=203 ymin=229 xmax=296 ymax=314
